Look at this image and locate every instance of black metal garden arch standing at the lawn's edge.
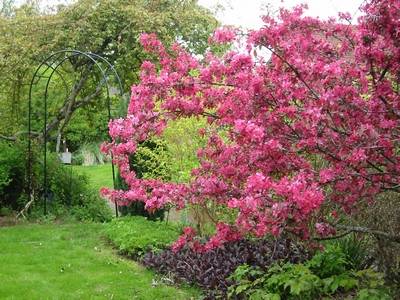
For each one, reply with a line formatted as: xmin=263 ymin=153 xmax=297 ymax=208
xmin=27 ymin=50 xmax=123 ymax=216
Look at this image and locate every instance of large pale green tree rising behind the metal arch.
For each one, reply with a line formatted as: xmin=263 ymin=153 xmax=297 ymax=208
xmin=0 ymin=0 xmax=217 ymax=145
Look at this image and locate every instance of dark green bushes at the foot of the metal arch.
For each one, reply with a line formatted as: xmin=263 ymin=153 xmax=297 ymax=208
xmin=0 ymin=142 xmax=112 ymax=222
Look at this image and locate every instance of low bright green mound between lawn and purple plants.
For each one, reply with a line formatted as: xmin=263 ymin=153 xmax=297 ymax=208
xmin=105 ymin=216 xmax=180 ymax=258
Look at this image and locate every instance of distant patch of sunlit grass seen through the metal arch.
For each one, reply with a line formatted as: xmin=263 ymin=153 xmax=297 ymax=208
xmin=72 ymin=164 xmax=117 ymax=191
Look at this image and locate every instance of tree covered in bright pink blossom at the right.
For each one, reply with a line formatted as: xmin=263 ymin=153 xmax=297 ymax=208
xmin=103 ymin=0 xmax=400 ymax=251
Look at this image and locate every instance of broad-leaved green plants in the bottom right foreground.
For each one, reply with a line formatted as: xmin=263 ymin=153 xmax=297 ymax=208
xmin=228 ymin=245 xmax=392 ymax=299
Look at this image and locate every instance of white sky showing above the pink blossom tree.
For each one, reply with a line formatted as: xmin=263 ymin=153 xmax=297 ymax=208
xmin=199 ymin=0 xmax=363 ymax=29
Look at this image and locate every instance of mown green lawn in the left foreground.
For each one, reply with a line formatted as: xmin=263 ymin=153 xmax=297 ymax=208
xmin=0 ymin=224 xmax=200 ymax=300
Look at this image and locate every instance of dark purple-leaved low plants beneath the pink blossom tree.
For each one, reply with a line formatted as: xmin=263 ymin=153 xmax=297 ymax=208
xmin=141 ymin=239 xmax=308 ymax=299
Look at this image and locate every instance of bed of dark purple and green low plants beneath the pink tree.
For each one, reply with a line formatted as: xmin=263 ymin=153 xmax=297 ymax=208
xmin=140 ymin=238 xmax=396 ymax=300
